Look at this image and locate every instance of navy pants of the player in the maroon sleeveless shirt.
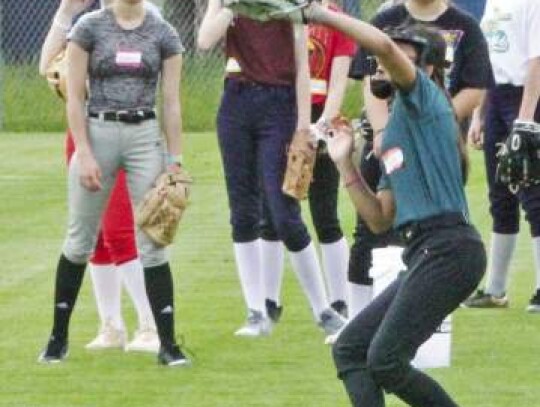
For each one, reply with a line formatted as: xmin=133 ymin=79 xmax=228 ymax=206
xmin=217 ymin=79 xmax=311 ymax=252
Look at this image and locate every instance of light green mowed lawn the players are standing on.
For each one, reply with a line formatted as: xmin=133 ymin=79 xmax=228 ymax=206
xmin=0 ymin=133 xmax=540 ymax=407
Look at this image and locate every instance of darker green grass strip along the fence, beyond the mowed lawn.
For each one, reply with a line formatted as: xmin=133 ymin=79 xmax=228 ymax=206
xmin=0 ymin=61 xmax=360 ymax=132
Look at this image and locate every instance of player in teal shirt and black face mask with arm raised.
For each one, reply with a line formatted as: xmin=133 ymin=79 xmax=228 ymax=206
xmin=300 ymin=6 xmax=486 ymax=407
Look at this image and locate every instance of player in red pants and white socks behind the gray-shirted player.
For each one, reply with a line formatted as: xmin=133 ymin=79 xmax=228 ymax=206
xmin=40 ymin=0 xmax=159 ymax=352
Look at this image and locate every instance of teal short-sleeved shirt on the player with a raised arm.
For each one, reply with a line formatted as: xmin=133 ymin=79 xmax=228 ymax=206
xmin=379 ymin=70 xmax=468 ymax=227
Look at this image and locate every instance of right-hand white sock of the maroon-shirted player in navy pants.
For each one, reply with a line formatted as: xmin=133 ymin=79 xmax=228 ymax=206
xmin=289 ymin=242 xmax=329 ymax=321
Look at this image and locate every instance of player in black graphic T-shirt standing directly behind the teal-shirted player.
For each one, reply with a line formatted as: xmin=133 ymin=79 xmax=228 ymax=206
xmin=349 ymin=0 xmax=493 ymax=315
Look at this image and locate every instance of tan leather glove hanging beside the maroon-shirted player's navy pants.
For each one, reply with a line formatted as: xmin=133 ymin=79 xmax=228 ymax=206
xmin=282 ymin=130 xmax=317 ymax=200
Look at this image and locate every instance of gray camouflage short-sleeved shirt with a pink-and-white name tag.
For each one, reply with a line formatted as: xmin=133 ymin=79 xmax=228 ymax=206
xmin=69 ymin=9 xmax=184 ymax=112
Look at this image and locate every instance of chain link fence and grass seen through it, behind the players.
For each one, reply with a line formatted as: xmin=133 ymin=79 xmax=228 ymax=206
xmin=0 ymin=0 xmax=383 ymax=131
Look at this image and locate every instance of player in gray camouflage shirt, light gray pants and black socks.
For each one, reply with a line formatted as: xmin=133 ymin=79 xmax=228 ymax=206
xmin=40 ymin=0 xmax=188 ymax=366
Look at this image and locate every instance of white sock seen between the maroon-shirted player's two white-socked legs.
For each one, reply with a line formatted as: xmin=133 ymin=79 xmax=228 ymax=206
xmin=260 ymin=239 xmax=285 ymax=306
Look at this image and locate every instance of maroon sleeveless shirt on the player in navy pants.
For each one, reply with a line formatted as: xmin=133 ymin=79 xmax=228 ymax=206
xmin=226 ymin=17 xmax=296 ymax=86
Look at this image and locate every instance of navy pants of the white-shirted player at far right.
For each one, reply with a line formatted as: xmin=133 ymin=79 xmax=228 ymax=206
xmin=484 ymin=85 xmax=540 ymax=237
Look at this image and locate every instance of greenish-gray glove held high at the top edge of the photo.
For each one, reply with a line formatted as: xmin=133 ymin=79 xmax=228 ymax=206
xmin=223 ymin=0 xmax=309 ymax=22
